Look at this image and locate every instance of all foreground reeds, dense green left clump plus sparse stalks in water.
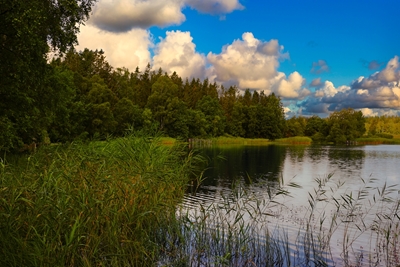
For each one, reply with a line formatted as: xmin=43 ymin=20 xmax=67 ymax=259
xmin=0 ymin=135 xmax=400 ymax=267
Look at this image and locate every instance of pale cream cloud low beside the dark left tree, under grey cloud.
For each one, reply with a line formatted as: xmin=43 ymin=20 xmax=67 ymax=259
xmin=76 ymin=25 xmax=152 ymax=71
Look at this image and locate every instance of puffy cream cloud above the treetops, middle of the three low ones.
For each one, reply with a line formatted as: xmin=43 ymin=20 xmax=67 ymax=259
xmin=153 ymin=31 xmax=206 ymax=78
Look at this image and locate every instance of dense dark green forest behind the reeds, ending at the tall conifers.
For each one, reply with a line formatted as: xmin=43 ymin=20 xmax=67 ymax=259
xmin=0 ymin=49 xmax=285 ymax=150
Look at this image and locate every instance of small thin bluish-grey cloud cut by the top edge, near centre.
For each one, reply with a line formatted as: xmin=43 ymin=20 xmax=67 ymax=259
xmin=185 ymin=0 xmax=244 ymax=15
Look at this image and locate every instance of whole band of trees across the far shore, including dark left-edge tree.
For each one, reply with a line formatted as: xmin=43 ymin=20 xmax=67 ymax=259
xmin=0 ymin=0 xmax=400 ymax=151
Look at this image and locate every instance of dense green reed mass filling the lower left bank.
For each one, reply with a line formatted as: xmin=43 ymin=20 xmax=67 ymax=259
xmin=0 ymin=136 xmax=200 ymax=266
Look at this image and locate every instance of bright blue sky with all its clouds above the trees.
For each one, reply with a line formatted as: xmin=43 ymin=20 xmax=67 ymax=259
xmin=76 ymin=0 xmax=400 ymax=117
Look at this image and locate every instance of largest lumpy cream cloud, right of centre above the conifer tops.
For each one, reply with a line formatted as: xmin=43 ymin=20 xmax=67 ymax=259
xmin=207 ymin=32 xmax=310 ymax=99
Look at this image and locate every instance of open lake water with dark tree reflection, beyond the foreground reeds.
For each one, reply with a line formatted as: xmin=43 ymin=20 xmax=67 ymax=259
xmin=185 ymin=145 xmax=400 ymax=266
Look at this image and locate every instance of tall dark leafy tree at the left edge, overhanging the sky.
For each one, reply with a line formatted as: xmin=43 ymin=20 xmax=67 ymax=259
xmin=0 ymin=0 xmax=95 ymax=150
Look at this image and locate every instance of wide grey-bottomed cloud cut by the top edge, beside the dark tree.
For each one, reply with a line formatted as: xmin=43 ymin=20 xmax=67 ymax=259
xmin=89 ymin=0 xmax=186 ymax=32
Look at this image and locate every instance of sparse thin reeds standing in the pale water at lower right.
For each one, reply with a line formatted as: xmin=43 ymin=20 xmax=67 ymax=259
xmin=160 ymin=175 xmax=400 ymax=267
